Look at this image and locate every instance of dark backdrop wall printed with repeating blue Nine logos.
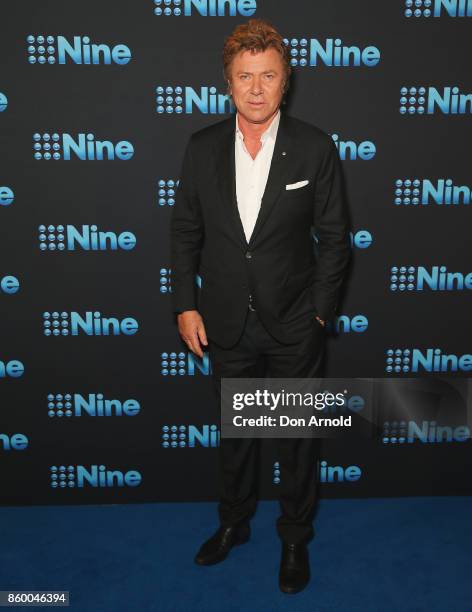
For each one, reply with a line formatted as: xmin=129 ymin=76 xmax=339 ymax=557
xmin=0 ymin=0 xmax=472 ymax=504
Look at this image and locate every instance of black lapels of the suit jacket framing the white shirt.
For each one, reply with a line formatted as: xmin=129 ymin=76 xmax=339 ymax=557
xmin=215 ymin=111 xmax=294 ymax=249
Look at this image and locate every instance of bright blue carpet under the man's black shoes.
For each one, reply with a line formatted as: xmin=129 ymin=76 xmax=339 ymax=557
xmin=0 ymin=497 xmax=472 ymax=612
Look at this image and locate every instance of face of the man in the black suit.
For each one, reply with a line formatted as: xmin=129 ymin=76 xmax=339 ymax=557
xmin=230 ymin=48 xmax=285 ymax=123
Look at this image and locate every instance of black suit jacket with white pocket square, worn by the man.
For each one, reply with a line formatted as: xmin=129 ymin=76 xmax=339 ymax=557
xmin=171 ymin=110 xmax=351 ymax=348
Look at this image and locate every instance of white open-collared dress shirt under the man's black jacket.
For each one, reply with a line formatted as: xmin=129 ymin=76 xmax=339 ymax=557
xmin=234 ymin=109 xmax=280 ymax=242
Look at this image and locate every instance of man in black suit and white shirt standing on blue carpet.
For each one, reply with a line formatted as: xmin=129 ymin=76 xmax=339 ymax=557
xmin=171 ymin=19 xmax=350 ymax=593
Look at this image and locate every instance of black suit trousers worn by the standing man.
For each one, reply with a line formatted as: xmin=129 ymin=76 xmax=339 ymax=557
xmin=208 ymin=310 xmax=326 ymax=543
